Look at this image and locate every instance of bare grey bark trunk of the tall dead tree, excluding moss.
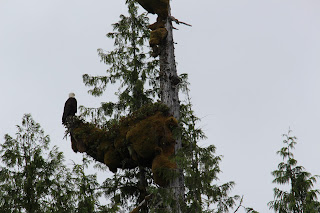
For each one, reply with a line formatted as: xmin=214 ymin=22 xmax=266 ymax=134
xmin=159 ymin=7 xmax=184 ymax=213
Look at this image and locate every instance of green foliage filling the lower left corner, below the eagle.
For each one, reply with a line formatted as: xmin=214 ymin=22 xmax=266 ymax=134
xmin=0 ymin=114 xmax=101 ymax=213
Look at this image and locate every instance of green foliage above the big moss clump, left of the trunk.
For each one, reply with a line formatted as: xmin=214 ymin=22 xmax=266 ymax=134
xmin=82 ymin=0 xmax=158 ymax=121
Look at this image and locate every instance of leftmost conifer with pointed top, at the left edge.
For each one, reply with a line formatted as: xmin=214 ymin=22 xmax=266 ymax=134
xmin=0 ymin=114 xmax=72 ymax=213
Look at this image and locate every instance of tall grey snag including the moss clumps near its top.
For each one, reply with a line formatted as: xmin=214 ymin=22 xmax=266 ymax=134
xmin=137 ymin=0 xmax=184 ymax=212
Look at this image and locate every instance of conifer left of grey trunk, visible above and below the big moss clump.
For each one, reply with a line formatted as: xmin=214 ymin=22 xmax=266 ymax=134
xmin=81 ymin=0 xmax=159 ymax=211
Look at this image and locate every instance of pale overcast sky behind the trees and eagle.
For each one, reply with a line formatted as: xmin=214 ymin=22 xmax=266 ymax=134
xmin=0 ymin=0 xmax=320 ymax=213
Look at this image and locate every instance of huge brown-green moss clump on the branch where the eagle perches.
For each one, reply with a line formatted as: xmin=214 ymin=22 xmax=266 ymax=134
xmin=69 ymin=103 xmax=178 ymax=181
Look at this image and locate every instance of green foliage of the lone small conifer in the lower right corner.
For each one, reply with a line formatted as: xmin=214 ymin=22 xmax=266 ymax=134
xmin=268 ymin=131 xmax=320 ymax=213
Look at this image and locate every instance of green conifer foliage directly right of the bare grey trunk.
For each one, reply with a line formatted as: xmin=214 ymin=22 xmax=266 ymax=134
xmin=179 ymin=80 xmax=239 ymax=213
